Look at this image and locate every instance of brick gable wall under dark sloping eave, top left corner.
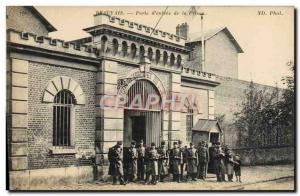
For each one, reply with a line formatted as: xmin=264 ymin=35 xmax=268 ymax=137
xmin=6 ymin=6 xmax=48 ymax=36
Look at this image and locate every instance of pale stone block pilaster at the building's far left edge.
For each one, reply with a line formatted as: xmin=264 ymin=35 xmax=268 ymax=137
xmin=7 ymin=58 xmax=29 ymax=172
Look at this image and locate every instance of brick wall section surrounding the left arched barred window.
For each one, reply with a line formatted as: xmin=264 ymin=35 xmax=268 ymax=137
xmin=28 ymin=62 xmax=96 ymax=169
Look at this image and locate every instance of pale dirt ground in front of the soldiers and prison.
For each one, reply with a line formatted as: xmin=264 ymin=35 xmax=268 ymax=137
xmin=34 ymin=165 xmax=294 ymax=191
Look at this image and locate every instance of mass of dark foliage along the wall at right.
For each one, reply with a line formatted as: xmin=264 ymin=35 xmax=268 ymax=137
xmin=234 ymin=64 xmax=295 ymax=147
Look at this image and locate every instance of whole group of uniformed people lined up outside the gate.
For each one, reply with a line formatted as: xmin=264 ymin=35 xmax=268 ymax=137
xmin=108 ymin=140 xmax=241 ymax=185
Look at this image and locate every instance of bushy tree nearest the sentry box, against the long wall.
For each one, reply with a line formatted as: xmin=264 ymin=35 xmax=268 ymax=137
xmin=234 ymin=81 xmax=277 ymax=147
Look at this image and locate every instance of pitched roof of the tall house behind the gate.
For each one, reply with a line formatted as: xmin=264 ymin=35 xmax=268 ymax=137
xmin=186 ymin=27 xmax=244 ymax=53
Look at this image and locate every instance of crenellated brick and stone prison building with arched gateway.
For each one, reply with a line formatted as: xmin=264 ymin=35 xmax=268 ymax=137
xmin=6 ymin=6 xmax=290 ymax=189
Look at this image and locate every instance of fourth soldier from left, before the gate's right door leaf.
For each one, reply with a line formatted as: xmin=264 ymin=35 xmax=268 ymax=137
xmin=146 ymin=143 xmax=159 ymax=185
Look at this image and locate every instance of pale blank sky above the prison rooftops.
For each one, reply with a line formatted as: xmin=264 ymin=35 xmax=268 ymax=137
xmin=36 ymin=6 xmax=294 ymax=87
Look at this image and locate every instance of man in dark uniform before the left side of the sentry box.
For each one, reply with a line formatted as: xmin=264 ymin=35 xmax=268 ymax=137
xmin=198 ymin=141 xmax=209 ymax=180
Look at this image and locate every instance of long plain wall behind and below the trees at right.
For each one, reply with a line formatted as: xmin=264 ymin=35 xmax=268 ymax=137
xmin=215 ymin=76 xmax=294 ymax=165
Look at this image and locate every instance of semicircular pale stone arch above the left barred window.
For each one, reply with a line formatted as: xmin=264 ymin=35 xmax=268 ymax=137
xmin=43 ymin=76 xmax=85 ymax=105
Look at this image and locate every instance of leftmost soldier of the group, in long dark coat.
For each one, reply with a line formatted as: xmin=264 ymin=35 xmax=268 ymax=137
xmin=108 ymin=141 xmax=126 ymax=185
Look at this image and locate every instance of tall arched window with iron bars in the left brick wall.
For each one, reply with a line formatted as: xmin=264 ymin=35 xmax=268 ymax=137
xmin=53 ymin=89 xmax=76 ymax=146
